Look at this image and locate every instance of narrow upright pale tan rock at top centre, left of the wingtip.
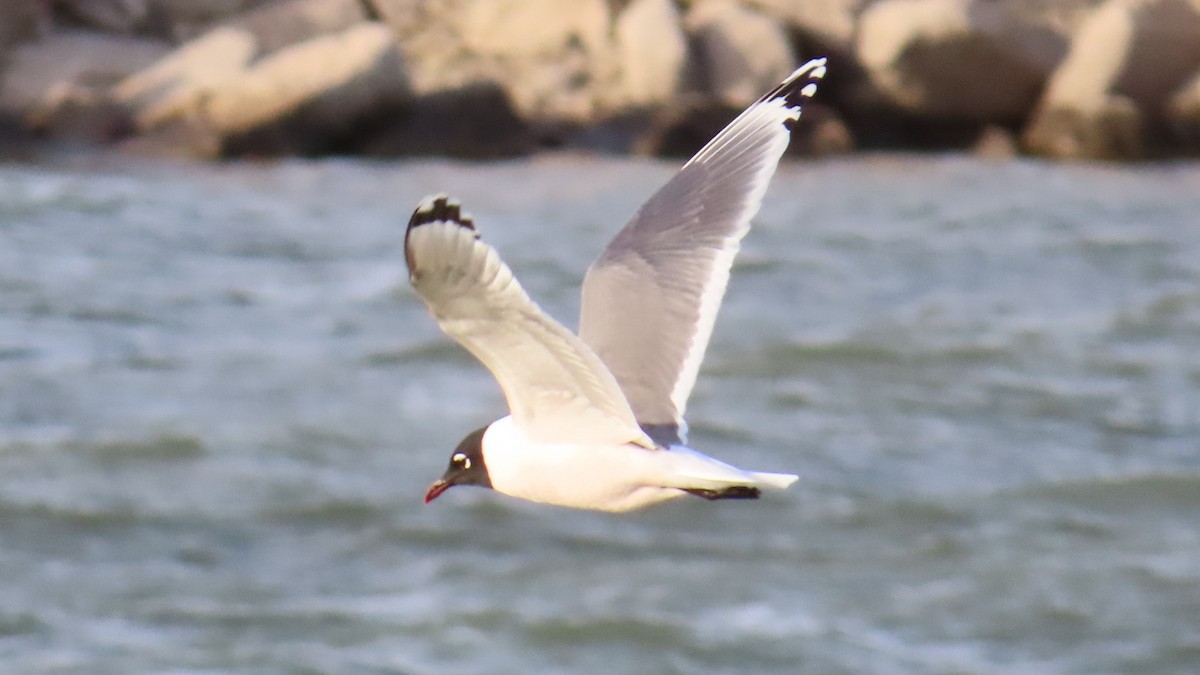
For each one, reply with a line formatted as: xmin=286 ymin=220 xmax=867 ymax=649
xmin=616 ymin=0 xmax=688 ymax=106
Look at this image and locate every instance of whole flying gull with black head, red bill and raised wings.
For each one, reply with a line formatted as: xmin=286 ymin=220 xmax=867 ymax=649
xmin=404 ymin=59 xmax=826 ymax=512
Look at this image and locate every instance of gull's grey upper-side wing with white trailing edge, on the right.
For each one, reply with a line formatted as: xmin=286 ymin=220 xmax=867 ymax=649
xmin=580 ymin=59 xmax=826 ymax=443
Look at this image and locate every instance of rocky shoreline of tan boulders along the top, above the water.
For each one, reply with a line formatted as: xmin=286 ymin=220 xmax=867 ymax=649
xmin=0 ymin=0 xmax=1200 ymax=160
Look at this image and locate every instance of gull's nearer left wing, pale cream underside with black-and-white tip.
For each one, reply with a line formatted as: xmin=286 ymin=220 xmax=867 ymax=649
xmin=404 ymin=196 xmax=654 ymax=447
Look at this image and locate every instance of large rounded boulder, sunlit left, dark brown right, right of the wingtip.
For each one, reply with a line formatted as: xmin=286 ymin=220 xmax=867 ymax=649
xmin=858 ymin=0 xmax=1067 ymax=123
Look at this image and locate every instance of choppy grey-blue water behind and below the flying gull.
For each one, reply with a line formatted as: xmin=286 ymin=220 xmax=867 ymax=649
xmin=0 ymin=156 xmax=1200 ymax=674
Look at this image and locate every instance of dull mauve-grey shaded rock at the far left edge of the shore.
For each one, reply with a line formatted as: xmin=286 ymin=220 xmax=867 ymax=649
xmin=0 ymin=31 xmax=169 ymax=141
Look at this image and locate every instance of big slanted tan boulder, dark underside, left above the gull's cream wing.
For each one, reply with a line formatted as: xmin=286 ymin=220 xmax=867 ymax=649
xmin=199 ymin=22 xmax=410 ymax=154
